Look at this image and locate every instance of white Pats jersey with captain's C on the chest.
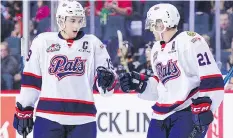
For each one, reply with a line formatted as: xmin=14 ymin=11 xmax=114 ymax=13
xmin=17 ymin=31 xmax=114 ymax=125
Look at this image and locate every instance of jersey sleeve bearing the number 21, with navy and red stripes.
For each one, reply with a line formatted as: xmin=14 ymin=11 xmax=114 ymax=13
xmin=184 ymin=35 xmax=224 ymax=111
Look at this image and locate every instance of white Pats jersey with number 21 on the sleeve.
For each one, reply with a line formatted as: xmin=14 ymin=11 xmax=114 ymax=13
xmin=139 ymin=31 xmax=224 ymax=120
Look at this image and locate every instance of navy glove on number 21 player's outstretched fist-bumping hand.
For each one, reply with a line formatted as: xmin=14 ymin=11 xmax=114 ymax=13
xmin=120 ymin=71 xmax=149 ymax=93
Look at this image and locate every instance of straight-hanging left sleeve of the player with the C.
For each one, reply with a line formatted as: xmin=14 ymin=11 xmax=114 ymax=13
xmin=17 ymin=36 xmax=43 ymax=107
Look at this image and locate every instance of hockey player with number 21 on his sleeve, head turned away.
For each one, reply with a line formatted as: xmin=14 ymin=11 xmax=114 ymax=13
xmin=120 ymin=4 xmax=224 ymax=138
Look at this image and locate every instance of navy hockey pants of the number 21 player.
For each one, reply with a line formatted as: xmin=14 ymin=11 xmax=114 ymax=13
xmin=147 ymin=107 xmax=208 ymax=138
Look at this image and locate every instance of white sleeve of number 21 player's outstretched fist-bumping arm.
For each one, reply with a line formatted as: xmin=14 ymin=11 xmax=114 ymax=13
xmin=138 ymin=44 xmax=159 ymax=101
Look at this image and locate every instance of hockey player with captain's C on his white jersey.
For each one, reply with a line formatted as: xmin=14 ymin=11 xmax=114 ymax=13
xmin=14 ymin=0 xmax=116 ymax=138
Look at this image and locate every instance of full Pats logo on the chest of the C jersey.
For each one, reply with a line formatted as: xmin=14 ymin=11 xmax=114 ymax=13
xmin=48 ymin=55 xmax=86 ymax=81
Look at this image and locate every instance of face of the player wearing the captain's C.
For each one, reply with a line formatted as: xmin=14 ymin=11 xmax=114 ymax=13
xmin=64 ymin=16 xmax=84 ymax=39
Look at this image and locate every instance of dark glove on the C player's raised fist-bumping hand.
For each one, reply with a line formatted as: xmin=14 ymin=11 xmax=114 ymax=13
xmin=96 ymin=66 xmax=115 ymax=91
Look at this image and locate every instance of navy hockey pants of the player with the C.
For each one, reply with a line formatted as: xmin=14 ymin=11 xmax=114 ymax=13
xmin=33 ymin=117 xmax=96 ymax=138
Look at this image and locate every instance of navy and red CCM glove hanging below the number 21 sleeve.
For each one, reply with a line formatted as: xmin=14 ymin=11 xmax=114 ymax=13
xmin=191 ymin=97 xmax=214 ymax=131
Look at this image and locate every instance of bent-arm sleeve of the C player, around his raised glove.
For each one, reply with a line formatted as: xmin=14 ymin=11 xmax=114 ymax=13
xmin=94 ymin=36 xmax=117 ymax=96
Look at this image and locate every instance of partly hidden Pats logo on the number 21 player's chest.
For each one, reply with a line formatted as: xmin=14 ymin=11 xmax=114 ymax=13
xmin=156 ymin=60 xmax=180 ymax=84
